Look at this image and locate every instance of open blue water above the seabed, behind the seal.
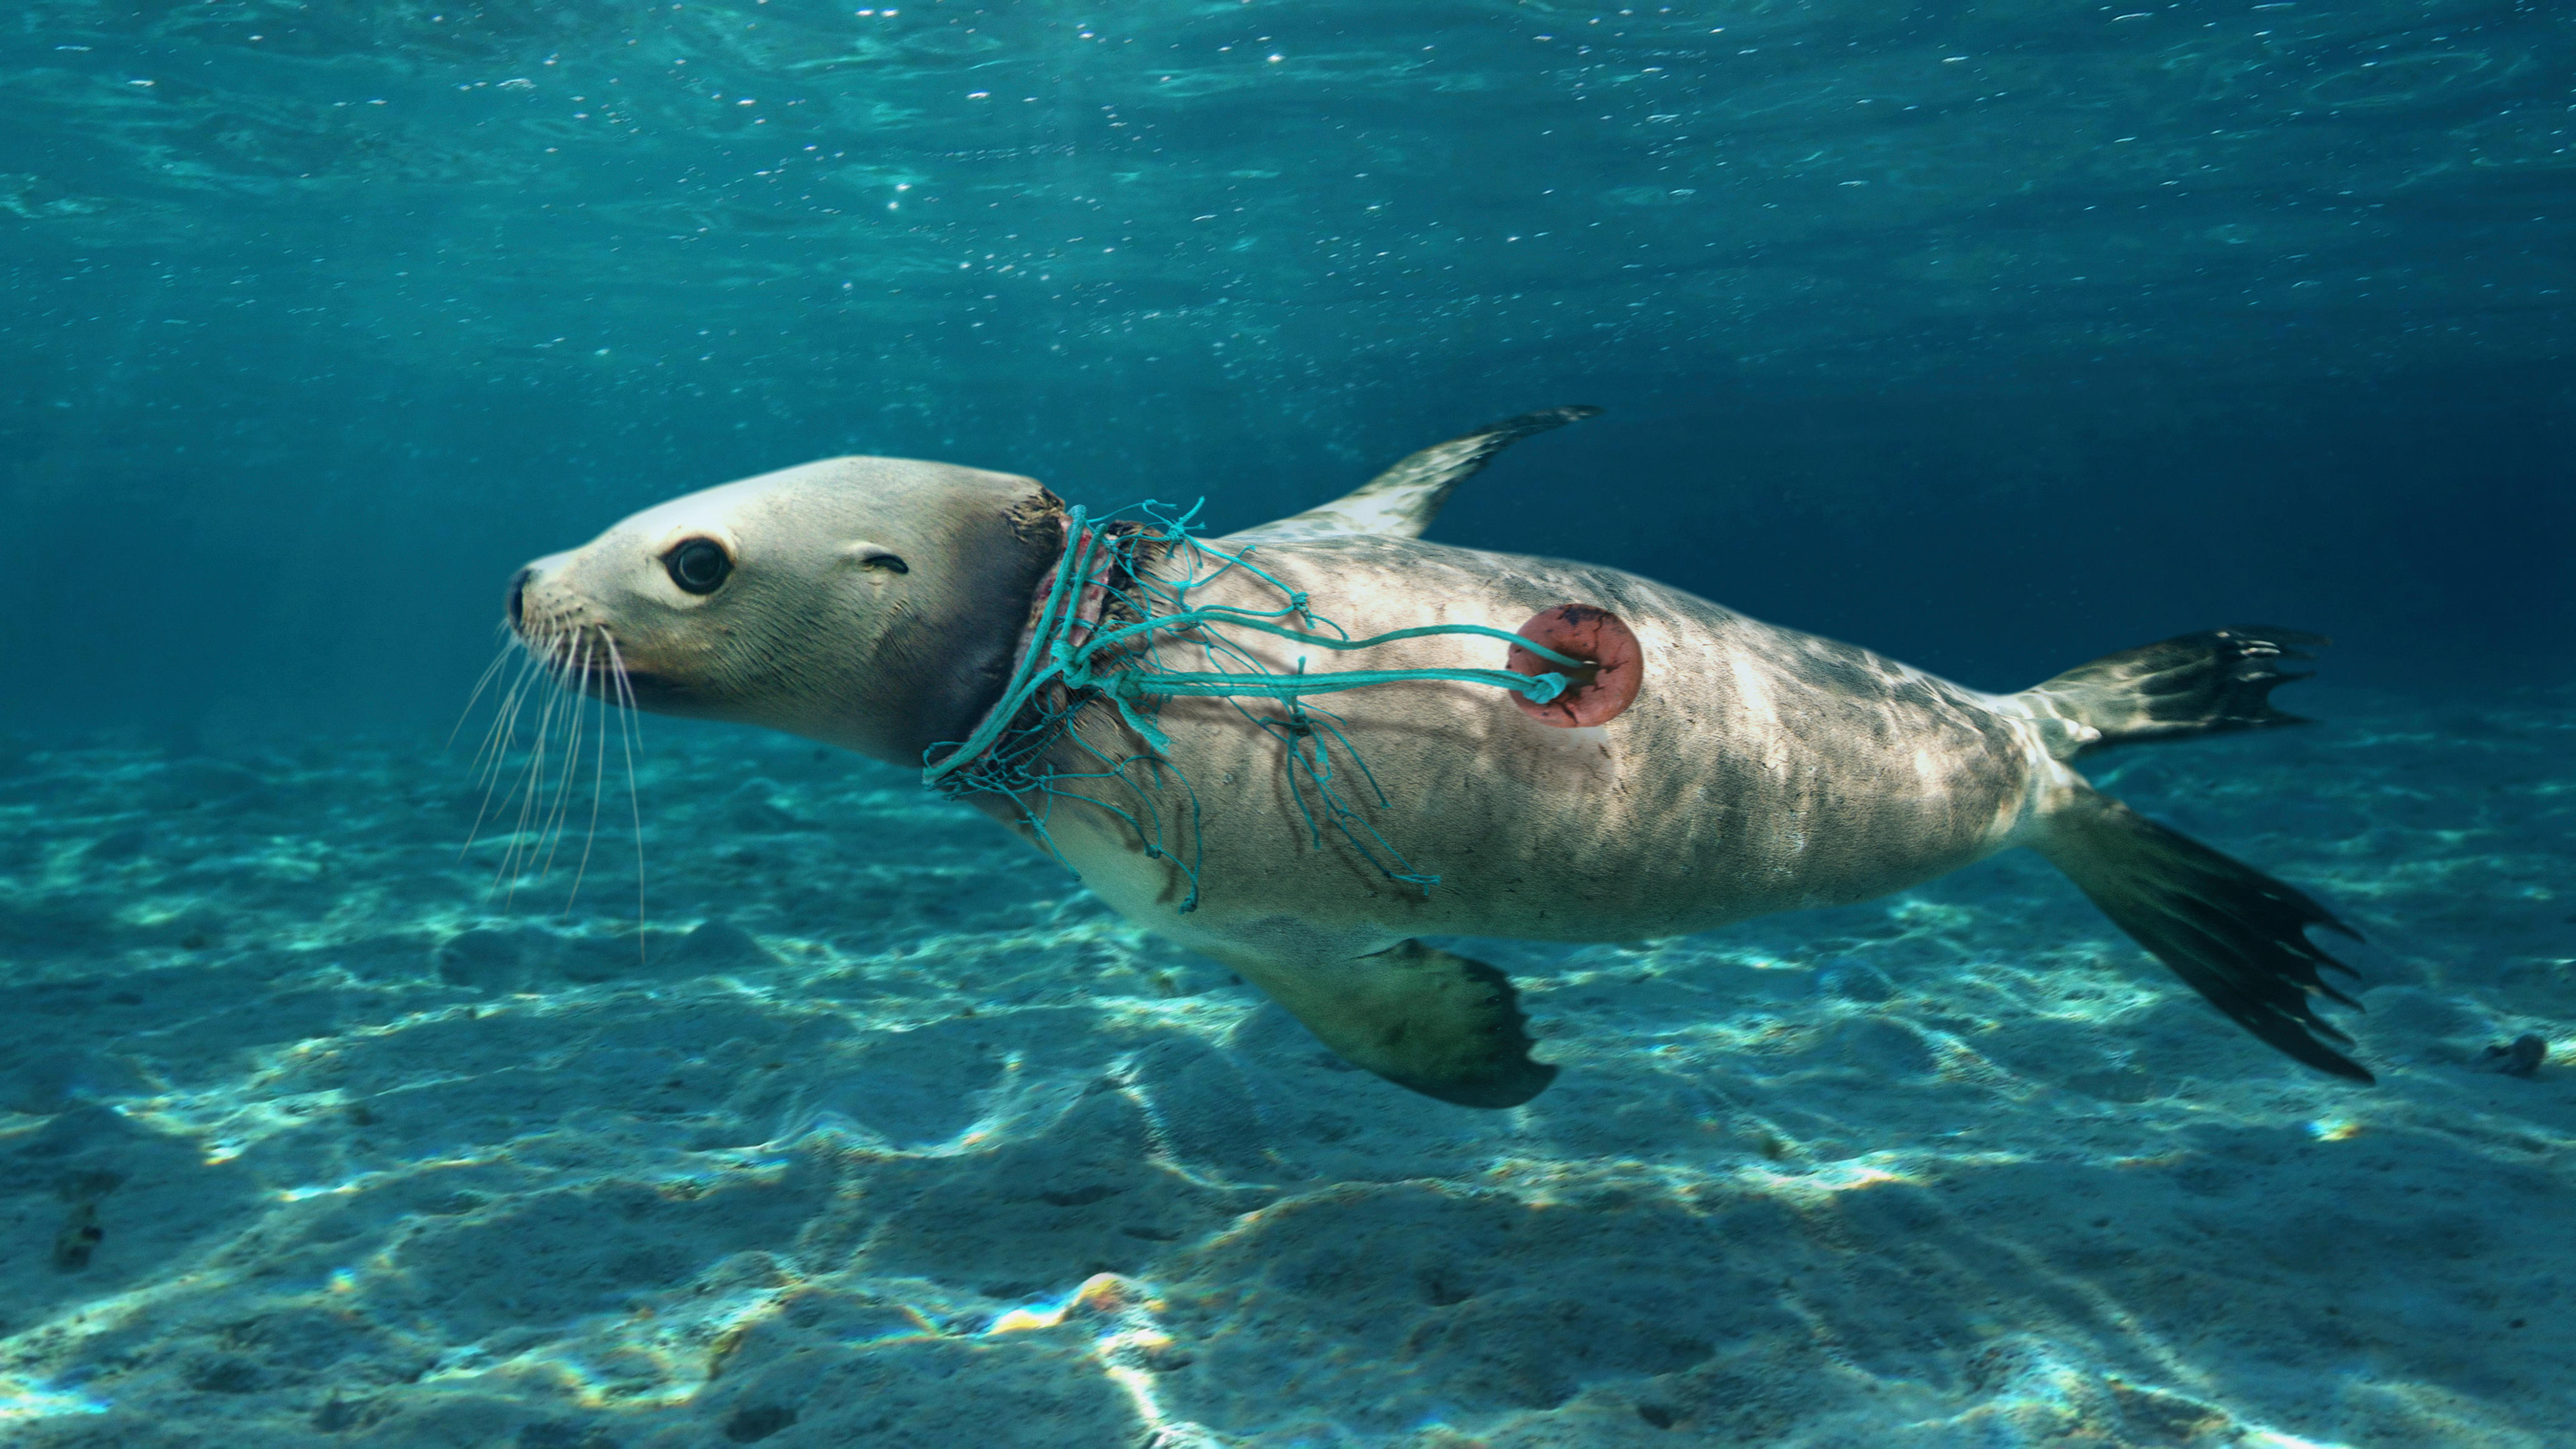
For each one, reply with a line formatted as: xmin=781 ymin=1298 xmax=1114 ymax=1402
xmin=0 ymin=0 xmax=2576 ymax=746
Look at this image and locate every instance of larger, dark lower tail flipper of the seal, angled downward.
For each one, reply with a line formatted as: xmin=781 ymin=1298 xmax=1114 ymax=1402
xmin=2035 ymin=790 xmax=2370 ymax=1081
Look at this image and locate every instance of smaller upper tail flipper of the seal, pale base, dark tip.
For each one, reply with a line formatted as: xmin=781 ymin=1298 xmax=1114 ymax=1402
xmin=2012 ymin=623 xmax=2329 ymax=759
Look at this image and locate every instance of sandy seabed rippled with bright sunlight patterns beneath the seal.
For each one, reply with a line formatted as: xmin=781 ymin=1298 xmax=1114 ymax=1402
xmin=0 ymin=690 xmax=2576 ymax=1449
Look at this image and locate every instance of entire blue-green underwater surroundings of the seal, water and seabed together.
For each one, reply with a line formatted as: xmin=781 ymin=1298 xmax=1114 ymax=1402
xmin=0 ymin=0 xmax=2576 ymax=1449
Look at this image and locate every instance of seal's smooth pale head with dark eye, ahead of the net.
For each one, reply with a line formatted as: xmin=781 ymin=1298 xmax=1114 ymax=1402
xmin=510 ymin=458 xmax=1064 ymax=764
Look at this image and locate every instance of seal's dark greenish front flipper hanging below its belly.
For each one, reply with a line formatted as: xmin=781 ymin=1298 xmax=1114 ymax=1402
xmin=1229 ymin=942 xmax=1556 ymax=1107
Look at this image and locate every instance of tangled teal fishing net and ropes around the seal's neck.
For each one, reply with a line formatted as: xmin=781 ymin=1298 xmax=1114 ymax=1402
xmin=922 ymin=499 xmax=1590 ymax=914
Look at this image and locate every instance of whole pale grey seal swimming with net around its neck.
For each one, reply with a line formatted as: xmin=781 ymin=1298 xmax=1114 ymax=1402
xmin=507 ymin=409 xmax=2370 ymax=1107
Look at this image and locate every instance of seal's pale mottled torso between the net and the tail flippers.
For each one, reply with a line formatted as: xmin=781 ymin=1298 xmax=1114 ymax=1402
xmin=1035 ymin=538 xmax=2035 ymax=939
